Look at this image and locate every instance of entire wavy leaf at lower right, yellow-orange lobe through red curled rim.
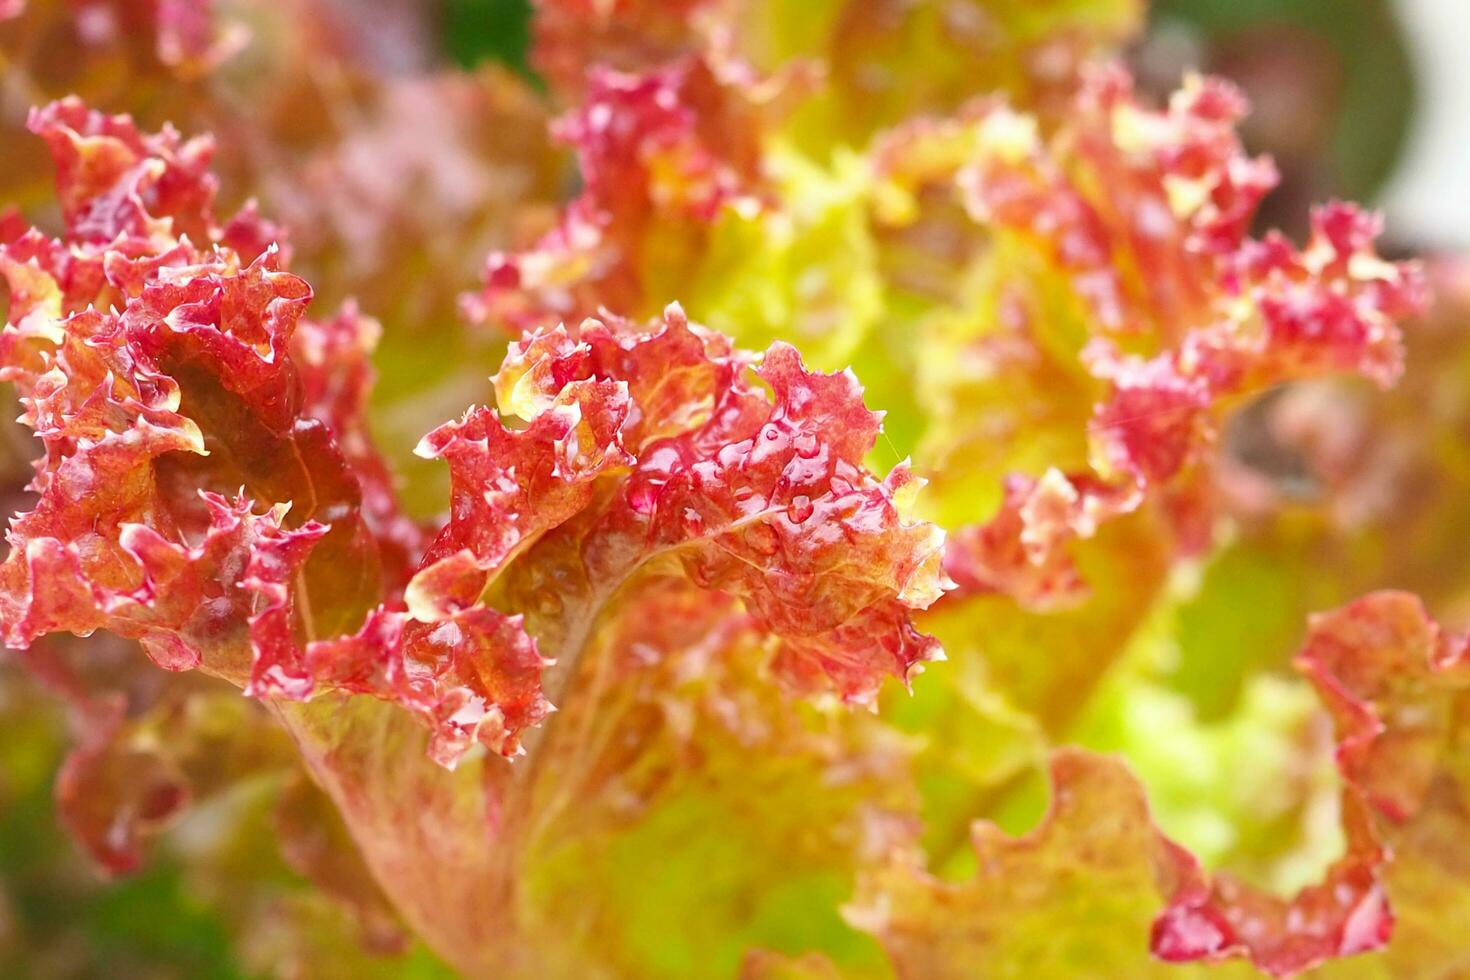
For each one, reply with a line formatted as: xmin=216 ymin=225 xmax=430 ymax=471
xmin=850 ymin=592 xmax=1470 ymax=977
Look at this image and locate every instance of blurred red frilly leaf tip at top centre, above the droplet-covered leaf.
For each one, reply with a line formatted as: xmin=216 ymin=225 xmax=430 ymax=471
xmin=463 ymin=56 xmax=776 ymax=334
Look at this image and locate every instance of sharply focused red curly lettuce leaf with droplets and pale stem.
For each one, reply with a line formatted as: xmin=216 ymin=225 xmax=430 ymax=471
xmin=0 ymin=94 xmax=948 ymax=970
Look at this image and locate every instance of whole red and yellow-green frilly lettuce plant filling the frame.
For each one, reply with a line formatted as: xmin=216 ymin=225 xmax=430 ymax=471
xmin=0 ymin=0 xmax=1470 ymax=979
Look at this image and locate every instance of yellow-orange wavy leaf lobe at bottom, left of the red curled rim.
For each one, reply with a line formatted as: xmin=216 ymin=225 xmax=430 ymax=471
xmin=845 ymin=751 xmax=1172 ymax=980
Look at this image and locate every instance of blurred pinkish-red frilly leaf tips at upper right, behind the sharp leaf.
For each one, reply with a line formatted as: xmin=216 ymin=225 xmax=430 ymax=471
xmin=934 ymin=69 xmax=1427 ymax=607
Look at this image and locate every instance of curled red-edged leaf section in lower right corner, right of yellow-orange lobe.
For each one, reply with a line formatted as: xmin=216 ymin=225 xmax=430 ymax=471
xmin=1152 ymin=592 xmax=1470 ymax=976
